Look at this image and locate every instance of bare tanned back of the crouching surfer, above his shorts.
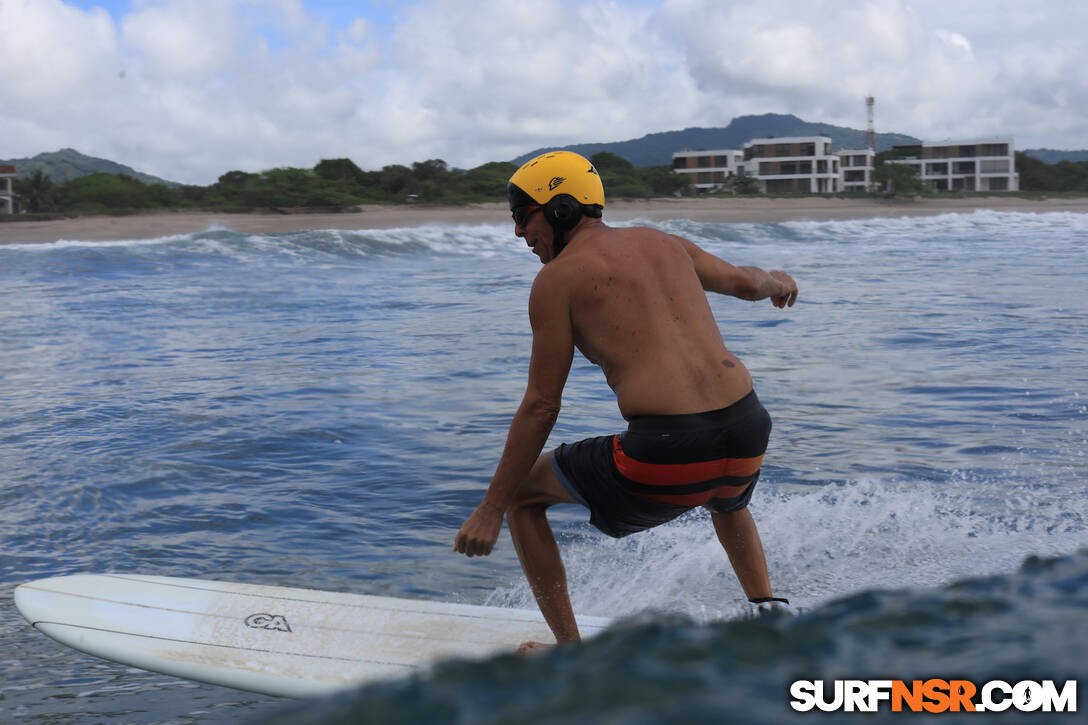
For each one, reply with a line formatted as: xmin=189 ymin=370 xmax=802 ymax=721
xmin=540 ymin=223 xmax=752 ymax=418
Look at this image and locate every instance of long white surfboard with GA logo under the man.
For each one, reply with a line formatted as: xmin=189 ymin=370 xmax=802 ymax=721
xmin=15 ymin=574 xmax=609 ymax=697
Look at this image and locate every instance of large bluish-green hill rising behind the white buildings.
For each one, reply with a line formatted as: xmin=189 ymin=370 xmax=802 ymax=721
xmin=514 ymin=113 xmax=920 ymax=167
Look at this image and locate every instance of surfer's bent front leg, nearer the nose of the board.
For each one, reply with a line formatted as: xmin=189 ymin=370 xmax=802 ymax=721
xmin=506 ymin=453 xmax=579 ymax=650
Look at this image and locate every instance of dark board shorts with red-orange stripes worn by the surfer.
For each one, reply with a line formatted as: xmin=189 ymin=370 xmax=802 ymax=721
xmin=552 ymin=391 xmax=770 ymax=539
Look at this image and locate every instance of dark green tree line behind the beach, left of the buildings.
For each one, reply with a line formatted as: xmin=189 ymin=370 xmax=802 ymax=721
xmin=8 ymin=151 xmax=687 ymax=213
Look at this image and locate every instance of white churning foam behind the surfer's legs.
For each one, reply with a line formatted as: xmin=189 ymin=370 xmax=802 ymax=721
xmin=489 ymin=476 xmax=1088 ymax=622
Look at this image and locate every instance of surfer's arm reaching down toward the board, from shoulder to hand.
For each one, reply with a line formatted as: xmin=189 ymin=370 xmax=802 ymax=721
xmin=454 ymin=271 xmax=574 ymax=556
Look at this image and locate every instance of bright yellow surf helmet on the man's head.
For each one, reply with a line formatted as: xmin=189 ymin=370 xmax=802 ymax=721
xmin=507 ymin=151 xmax=605 ymax=210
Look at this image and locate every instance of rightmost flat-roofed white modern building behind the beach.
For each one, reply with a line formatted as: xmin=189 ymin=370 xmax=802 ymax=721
xmin=887 ymin=138 xmax=1019 ymax=192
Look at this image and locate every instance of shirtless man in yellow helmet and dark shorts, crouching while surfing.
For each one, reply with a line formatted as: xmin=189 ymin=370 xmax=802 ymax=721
xmin=454 ymin=151 xmax=798 ymax=651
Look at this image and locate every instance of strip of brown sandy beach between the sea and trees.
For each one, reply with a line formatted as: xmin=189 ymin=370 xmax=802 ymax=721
xmin=0 ymin=196 xmax=1088 ymax=244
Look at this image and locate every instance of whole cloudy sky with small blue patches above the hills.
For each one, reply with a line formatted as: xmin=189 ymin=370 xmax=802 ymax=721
xmin=0 ymin=0 xmax=1088 ymax=184
